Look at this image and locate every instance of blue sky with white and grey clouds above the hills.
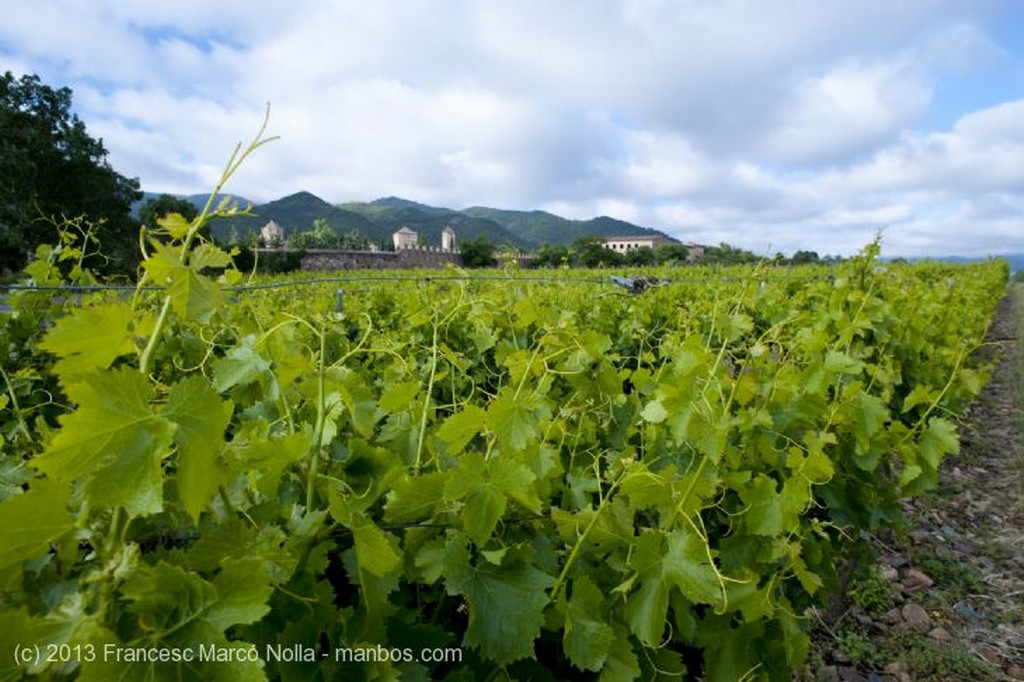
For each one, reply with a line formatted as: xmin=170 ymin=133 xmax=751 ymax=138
xmin=0 ymin=0 xmax=1024 ymax=257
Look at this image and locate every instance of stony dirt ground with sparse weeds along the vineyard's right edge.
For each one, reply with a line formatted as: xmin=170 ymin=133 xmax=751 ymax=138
xmin=801 ymin=286 xmax=1024 ymax=682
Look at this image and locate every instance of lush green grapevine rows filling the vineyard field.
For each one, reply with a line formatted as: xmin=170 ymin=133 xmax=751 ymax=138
xmin=0 ymin=142 xmax=1008 ymax=681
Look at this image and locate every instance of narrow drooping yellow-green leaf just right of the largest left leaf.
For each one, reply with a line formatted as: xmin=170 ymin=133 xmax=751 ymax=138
xmin=162 ymin=375 xmax=233 ymax=519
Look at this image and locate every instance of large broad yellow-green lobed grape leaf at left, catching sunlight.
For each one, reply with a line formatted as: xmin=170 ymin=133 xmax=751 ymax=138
xmin=34 ymin=369 xmax=174 ymax=516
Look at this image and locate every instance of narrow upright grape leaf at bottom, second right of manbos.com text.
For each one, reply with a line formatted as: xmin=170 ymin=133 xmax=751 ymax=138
xmin=562 ymin=576 xmax=615 ymax=673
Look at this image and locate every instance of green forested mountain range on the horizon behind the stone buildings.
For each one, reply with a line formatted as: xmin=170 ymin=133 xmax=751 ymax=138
xmin=136 ymin=191 xmax=676 ymax=250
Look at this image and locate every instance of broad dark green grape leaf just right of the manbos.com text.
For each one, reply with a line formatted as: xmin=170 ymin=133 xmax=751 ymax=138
xmin=444 ymin=536 xmax=555 ymax=666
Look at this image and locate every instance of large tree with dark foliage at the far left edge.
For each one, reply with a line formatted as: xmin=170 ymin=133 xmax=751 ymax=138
xmin=0 ymin=72 xmax=141 ymax=271
